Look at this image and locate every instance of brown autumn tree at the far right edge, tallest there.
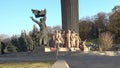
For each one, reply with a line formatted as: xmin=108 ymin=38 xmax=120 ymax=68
xmin=108 ymin=6 xmax=120 ymax=43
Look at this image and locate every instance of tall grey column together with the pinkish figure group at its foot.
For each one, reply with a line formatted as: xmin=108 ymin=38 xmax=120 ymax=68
xmin=46 ymin=0 xmax=84 ymax=51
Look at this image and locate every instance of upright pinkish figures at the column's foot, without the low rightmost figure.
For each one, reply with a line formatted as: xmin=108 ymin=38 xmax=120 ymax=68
xmin=53 ymin=30 xmax=81 ymax=48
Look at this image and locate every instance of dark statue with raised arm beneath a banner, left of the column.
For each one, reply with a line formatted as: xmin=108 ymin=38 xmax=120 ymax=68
xmin=30 ymin=9 xmax=47 ymax=45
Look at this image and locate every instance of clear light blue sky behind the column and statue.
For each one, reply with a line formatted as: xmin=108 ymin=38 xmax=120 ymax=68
xmin=0 ymin=0 xmax=120 ymax=36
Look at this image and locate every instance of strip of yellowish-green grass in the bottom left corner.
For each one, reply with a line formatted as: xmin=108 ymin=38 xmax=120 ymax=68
xmin=0 ymin=61 xmax=55 ymax=68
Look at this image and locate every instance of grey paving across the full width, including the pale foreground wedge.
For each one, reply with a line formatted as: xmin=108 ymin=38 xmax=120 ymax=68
xmin=0 ymin=53 xmax=120 ymax=68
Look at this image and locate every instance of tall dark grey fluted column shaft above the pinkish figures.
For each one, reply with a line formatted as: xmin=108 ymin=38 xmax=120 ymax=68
xmin=61 ymin=0 xmax=79 ymax=33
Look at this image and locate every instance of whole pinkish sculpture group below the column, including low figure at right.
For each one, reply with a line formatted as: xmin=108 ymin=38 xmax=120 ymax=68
xmin=50 ymin=30 xmax=86 ymax=51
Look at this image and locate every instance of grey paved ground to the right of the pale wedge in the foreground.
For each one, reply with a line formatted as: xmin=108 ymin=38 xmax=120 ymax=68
xmin=59 ymin=55 xmax=120 ymax=68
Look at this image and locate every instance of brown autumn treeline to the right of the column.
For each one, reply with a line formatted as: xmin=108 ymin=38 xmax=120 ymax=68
xmin=79 ymin=10 xmax=120 ymax=43
